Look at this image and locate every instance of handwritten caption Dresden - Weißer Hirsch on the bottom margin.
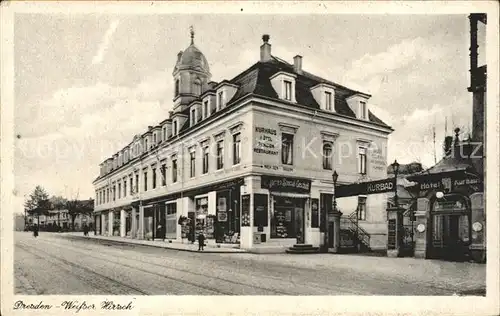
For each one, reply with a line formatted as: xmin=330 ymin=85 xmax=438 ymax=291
xmin=14 ymin=299 xmax=134 ymax=313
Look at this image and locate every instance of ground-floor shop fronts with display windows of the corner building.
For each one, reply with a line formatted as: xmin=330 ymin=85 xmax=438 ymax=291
xmin=95 ymin=175 xmax=374 ymax=249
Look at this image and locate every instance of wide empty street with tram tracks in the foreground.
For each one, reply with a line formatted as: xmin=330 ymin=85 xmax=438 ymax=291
xmin=14 ymin=232 xmax=486 ymax=295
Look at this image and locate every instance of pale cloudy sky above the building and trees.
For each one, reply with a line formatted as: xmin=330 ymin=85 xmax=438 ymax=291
xmin=14 ymin=13 xmax=484 ymax=207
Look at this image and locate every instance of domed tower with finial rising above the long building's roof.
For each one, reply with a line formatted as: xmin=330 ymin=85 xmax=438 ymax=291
xmin=172 ymin=27 xmax=212 ymax=112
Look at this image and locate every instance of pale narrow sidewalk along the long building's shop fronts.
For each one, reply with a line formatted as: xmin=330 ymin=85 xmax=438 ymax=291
xmin=60 ymin=232 xmax=246 ymax=253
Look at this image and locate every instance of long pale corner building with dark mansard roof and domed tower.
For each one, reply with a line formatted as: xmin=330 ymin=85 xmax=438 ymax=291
xmin=93 ymin=32 xmax=392 ymax=249
